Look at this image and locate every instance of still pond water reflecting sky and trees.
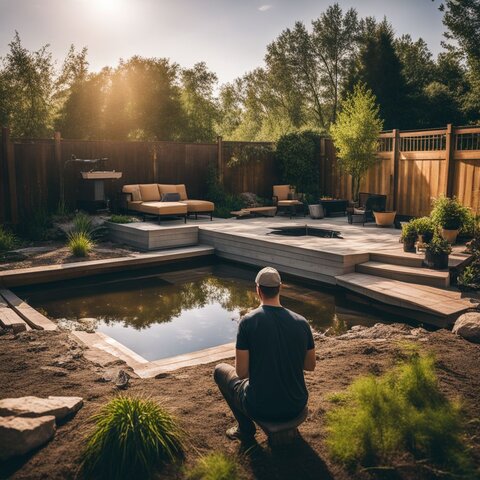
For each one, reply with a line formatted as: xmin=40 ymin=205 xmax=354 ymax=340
xmin=16 ymin=263 xmax=398 ymax=360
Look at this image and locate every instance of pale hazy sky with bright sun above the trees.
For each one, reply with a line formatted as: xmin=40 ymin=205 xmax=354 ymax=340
xmin=0 ymin=0 xmax=445 ymax=83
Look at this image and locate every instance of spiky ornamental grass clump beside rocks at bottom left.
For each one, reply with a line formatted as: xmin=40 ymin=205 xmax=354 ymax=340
xmin=83 ymin=396 xmax=184 ymax=479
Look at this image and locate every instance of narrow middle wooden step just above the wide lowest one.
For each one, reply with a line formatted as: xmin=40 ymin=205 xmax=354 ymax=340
xmin=355 ymin=261 xmax=450 ymax=288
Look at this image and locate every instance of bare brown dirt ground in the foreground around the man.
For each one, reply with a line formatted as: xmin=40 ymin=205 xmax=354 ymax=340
xmin=0 ymin=325 xmax=480 ymax=480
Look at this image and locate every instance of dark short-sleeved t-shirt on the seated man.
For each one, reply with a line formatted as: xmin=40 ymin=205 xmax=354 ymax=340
xmin=236 ymin=305 xmax=315 ymax=421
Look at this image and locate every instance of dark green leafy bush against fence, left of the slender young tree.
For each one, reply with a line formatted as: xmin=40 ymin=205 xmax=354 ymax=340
xmin=275 ymin=130 xmax=320 ymax=198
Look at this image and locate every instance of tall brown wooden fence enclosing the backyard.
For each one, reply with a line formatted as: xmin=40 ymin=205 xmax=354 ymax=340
xmin=0 ymin=125 xmax=480 ymax=223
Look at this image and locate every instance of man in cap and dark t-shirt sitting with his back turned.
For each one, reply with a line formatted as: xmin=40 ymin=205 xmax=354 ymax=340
xmin=214 ymin=267 xmax=316 ymax=441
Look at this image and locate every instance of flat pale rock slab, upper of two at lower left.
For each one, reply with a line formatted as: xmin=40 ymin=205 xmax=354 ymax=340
xmin=0 ymin=396 xmax=83 ymax=420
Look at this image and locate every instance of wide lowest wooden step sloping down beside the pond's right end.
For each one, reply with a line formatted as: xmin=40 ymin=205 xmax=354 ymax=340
xmin=336 ymin=273 xmax=474 ymax=325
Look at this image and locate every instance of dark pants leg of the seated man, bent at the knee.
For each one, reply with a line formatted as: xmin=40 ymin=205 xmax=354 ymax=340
xmin=213 ymin=363 xmax=256 ymax=435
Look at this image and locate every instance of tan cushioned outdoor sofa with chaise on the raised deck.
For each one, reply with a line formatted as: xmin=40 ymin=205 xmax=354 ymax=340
xmin=122 ymin=183 xmax=215 ymax=222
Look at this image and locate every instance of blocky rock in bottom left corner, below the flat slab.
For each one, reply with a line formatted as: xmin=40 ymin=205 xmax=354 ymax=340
xmin=0 ymin=415 xmax=55 ymax=461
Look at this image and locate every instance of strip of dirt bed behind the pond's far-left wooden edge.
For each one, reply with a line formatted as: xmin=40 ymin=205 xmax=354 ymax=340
xmin=0 ymin=241 xmax=136 ymax=270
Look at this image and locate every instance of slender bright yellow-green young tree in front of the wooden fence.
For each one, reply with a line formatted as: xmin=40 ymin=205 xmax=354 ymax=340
xmin=330 ymin=84 xmax=383 ymax=201
